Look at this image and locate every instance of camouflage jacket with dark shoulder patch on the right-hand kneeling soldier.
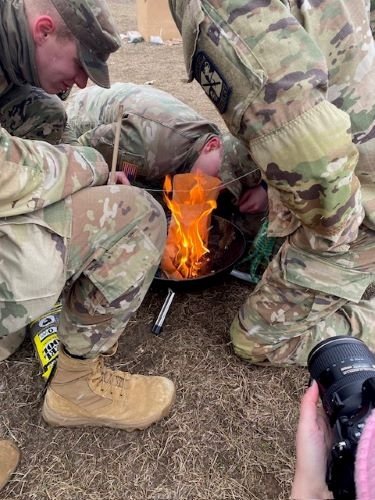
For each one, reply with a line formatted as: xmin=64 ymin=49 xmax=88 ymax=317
xmin=169 ymin=0 xmax=375 ymax=253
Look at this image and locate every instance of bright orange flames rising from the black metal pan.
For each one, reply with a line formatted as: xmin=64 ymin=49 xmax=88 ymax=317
xmin=161 ymin=172 xmax=221 ymax=279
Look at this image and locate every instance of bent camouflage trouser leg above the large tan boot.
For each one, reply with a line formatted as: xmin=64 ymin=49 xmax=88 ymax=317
xmin=0 ymin=186 xmax=166 ymax=358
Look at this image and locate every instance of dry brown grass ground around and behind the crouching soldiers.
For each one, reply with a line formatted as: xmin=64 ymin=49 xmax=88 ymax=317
xmin=0 ymin=0 xmax=307 ymax=500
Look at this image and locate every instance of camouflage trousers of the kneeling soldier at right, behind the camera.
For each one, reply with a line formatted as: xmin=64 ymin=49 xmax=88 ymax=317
xmin=230 ymin=226 xmax=375 ymax=365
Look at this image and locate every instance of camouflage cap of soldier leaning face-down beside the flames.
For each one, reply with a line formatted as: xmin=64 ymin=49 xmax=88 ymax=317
xmin=219 ymin=133 xmax=261 ymax=201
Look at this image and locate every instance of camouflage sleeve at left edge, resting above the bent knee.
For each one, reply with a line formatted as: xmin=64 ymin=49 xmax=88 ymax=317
xmin=0 ymin=128 xmax=108 ymax=217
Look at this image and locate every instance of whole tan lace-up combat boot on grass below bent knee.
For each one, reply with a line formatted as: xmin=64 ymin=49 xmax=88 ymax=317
xmin=43 ymin=349 xmax=175 ymax=431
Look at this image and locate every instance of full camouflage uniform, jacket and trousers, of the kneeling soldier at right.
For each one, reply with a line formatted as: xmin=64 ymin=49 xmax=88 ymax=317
xmin=169 ymin=0 xmax=375 ymax=364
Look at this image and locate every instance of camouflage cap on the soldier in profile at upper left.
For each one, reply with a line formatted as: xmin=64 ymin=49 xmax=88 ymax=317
xmin=51 ymin=0 xmax=121 ymax=88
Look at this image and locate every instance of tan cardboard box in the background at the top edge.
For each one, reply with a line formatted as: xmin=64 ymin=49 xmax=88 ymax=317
xmin=137 ymin=0 xmax=181 ymax=42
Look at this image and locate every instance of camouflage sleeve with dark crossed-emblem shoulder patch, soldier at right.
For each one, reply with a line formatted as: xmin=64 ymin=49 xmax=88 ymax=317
xmin=169 ymin=0 xmax=363 ymax=251
